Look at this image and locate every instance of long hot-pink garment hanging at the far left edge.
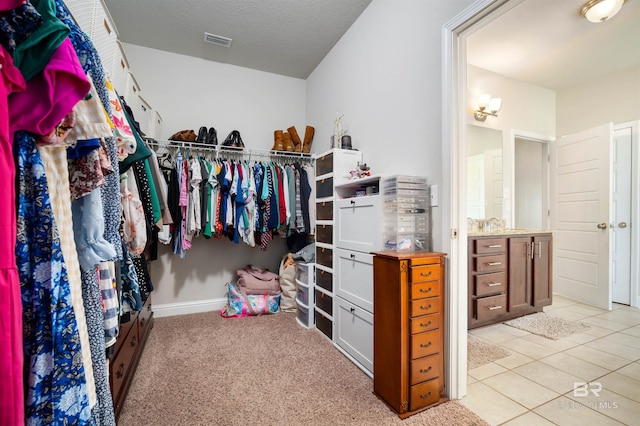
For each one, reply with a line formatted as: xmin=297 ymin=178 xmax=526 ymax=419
xmin=0 ymin=43 xmax=25 ymax=426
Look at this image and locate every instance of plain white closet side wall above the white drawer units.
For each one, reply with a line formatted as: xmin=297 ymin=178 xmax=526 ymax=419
xmin=307 ymin=0 xmax=472 ymax=250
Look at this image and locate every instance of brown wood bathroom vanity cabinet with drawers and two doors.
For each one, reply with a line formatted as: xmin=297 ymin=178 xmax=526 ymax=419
xmin=468 ymin=234 xmax=553 ymax=328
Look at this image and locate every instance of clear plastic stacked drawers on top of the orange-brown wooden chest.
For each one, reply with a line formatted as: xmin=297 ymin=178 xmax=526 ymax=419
xmin=381 ymin=176 xmax=431 ymax=251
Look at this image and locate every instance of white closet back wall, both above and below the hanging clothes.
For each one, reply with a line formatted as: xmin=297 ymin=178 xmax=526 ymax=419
xmin=125 ymin=44 xmax=306 ymax=314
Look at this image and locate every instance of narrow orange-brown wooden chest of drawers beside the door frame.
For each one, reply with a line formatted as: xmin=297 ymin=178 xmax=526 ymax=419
xmin=373 ymin=252 xmax=447 ymax=418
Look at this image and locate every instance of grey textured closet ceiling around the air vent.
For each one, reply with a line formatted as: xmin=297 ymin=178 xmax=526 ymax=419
xmin=104 ymin=0 xmax=371 ymax=79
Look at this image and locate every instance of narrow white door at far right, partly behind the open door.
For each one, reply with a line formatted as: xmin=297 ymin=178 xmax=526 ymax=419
xmin=610 ymin=127 xmax=633 ymax=305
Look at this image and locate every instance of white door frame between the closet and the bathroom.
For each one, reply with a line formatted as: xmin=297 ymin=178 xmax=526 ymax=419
xmin=441 ymin=0 xmax=524 ymax=399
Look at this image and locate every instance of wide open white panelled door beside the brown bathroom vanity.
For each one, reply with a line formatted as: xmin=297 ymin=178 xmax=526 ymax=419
xmin=551 ymin=123 xmax=613 ymax=309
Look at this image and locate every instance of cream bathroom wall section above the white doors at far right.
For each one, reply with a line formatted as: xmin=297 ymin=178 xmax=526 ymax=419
xmin=557 ymin=65 xmax=640 ymax=136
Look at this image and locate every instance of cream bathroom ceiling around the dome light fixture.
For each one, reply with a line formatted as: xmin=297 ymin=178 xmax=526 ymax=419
xmin=467 ymin=0 xmax=640 ymax=91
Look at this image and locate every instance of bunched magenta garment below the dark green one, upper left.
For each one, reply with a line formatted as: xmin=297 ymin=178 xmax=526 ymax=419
xmin=9 ymin=38 xmax=91 ymax=135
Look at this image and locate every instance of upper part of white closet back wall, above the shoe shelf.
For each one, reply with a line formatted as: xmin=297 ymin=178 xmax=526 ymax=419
xmin=124 ymin=43 xmax=306 ymax=149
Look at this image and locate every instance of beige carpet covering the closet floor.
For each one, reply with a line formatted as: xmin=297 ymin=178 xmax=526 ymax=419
xmin=118 ymin=312 xmax=487 ymax=426
